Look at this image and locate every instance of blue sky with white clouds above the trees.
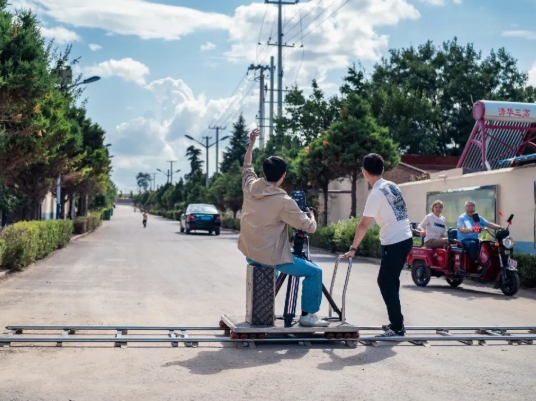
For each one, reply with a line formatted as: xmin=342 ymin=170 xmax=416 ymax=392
xmin=7 ymin=0 xmax=536 ymax=192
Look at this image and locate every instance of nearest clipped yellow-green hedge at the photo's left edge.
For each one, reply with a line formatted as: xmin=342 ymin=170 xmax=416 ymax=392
xmin=0 ymin=220 xmax=73 ymax=270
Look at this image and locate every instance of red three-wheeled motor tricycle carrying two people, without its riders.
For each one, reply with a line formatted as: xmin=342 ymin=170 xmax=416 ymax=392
xmin=407 ymin=213 xmax=519 ymax=296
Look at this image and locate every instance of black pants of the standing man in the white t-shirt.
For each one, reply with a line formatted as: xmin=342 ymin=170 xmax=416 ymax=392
xmin=378 ymin=238 xmax=413 ymax=331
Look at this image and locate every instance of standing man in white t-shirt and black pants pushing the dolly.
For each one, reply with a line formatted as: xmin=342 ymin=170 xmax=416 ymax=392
xmin=344 ymin=153 xmax=413 ymax=337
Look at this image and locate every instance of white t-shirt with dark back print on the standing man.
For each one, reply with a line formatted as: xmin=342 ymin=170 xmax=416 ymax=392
xmin=363 ymin=178 xmax=413 ymax=245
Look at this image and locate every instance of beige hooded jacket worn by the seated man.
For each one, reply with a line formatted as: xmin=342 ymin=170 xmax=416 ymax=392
xmin=238 ymin=164 xmax=316 ymax=266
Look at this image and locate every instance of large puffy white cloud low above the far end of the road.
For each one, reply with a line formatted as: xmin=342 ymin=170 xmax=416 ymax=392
xmin=107 ymin=77 xmax=258 ymax=188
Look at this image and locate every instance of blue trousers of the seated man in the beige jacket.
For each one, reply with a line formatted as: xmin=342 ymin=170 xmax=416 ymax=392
xmin=246 ymin=255 xmax=322 ymax=313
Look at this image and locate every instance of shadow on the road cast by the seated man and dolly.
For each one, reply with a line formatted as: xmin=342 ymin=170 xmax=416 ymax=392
xmin=162 ymin=346 xmax=309 ymax=375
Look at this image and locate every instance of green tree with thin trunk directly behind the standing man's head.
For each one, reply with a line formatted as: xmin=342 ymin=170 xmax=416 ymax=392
xmin=329 ymin=94 xmax=400 ymax=217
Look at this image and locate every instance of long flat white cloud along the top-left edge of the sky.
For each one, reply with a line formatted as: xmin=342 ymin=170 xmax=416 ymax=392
xmin=13 ymin=0 xmax=232 ymax=40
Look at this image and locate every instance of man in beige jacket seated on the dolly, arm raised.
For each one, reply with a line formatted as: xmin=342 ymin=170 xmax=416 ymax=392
xmin=238 ymin=130 xmax=328 ymax=327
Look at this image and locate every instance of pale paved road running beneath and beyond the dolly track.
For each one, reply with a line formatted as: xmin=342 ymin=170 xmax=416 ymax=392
xmin=0 ymin=206 xmax=536 ymax=401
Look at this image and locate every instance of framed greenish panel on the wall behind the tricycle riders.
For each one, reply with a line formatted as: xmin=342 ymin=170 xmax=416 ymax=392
xmin=426 ymin=185 xmax=498 ymax=228
